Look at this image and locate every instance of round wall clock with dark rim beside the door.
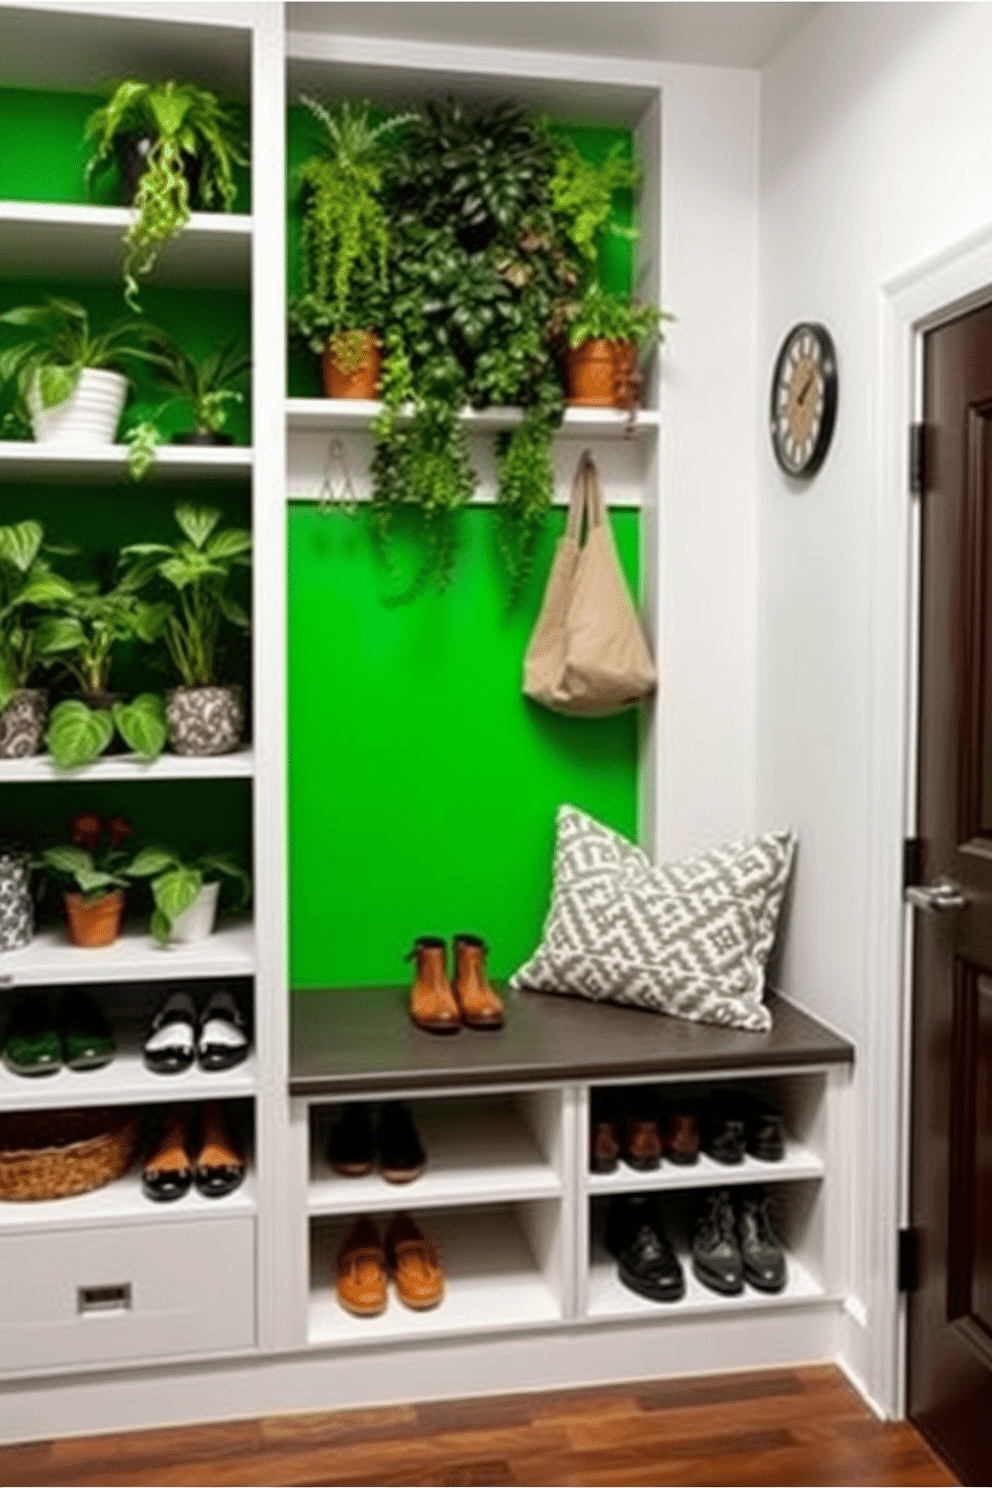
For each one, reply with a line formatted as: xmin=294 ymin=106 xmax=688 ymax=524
xmin=770 ymin=321 xmax=837 ymax=479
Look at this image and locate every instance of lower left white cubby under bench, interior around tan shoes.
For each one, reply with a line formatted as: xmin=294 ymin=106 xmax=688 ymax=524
xmin=308 ymin=1190 xmax=570 ymax=1345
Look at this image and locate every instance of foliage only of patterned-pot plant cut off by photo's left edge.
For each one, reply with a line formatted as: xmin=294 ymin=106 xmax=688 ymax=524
xmin=0 ymin=521 xmax=73 ymax=708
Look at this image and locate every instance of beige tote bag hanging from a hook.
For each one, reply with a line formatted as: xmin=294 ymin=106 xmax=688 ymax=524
xmin=524 ymin=449 xmax=657 ymax=719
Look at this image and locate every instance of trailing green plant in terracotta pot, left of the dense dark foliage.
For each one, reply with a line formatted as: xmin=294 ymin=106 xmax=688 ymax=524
xmin=290 ymin=97 xmax=412 ymax=399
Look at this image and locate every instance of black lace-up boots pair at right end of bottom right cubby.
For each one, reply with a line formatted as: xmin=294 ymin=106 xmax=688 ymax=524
xmin=692 ymin=1189 xmax=787 ymax=1296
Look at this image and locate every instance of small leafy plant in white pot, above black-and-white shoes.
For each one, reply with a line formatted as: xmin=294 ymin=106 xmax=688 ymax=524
xmin=126 ymin=847 xmax=251 ymax=945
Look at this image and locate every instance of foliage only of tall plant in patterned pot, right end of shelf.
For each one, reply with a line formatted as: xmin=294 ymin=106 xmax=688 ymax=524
xmin=120 ymin=501 xmax=251 ymax=687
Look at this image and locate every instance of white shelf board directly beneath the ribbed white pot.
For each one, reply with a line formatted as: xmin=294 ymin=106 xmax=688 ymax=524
xmin=0 ymin=437 xmax=254 ymax=485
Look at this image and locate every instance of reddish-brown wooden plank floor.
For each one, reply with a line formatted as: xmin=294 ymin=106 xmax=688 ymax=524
xmin=0 ymin=1364 xmax=958 ymax=1488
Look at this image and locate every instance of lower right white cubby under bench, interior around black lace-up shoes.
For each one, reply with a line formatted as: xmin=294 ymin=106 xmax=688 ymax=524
xmin=584 ymin=1180 xmax=827 ymax=1320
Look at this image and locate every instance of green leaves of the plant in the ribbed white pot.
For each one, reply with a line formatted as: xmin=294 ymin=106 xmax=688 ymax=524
xmin=0 ymin=295 xmax=158 ymax=420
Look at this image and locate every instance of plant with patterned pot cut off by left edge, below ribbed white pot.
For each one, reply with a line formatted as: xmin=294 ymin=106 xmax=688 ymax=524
xmin=0 ymin=522 xmax=71 ymax=759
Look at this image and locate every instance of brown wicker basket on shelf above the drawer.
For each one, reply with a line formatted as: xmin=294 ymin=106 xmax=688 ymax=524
xmin=0 ymin=1106 xmax=140 ymax=1202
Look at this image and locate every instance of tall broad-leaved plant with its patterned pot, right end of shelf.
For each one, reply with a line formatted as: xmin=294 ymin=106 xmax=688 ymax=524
xmin=120 ymin=501 xmax=251 ymax=754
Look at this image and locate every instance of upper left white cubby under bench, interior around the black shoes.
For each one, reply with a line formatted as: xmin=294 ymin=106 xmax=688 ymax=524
xmin=308 ymin=1089 xmax=565 ymax=1214
